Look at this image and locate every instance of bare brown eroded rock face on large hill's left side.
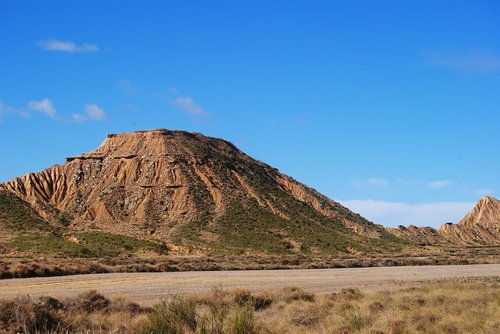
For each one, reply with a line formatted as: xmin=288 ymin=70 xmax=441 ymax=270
xmin=0 ymin=130 xmax=232 ymax=231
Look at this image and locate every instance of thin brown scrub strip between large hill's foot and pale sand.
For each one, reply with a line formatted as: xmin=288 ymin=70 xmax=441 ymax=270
xmin=0 ymin=246 xmax=500 ymax=279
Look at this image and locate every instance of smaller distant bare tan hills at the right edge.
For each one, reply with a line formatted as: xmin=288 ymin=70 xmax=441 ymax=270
xmin=387 ymin=196 xmax=500 ymax=246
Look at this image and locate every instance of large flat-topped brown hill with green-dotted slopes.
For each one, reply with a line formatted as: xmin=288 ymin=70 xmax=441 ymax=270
xmin=0 ymin=129 xmax=408 ymax=254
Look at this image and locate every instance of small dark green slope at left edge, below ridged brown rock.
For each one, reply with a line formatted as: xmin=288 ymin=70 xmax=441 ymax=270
xmin=0 ymin=191 xmax=49 ymax=231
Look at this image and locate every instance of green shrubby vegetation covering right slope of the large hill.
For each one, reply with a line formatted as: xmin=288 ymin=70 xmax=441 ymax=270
xmin=170 ymin=148 xmax=415 ymax=255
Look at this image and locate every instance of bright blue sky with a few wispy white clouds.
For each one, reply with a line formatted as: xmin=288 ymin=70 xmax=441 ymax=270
xmin=0 ymin=0 xmax=500 ymax=226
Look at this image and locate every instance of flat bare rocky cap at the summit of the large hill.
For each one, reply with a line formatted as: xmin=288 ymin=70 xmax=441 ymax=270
xmin=67 ymin=129 xmax=241 ymax=161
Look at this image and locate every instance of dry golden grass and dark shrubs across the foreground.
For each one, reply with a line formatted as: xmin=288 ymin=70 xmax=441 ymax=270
xmin=0 ymin=277 xmax=500 ymax=334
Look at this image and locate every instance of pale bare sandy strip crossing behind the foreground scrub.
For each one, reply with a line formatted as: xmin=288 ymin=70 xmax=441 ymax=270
xmin=0 ymin=264 xmax=500 ymax=305
